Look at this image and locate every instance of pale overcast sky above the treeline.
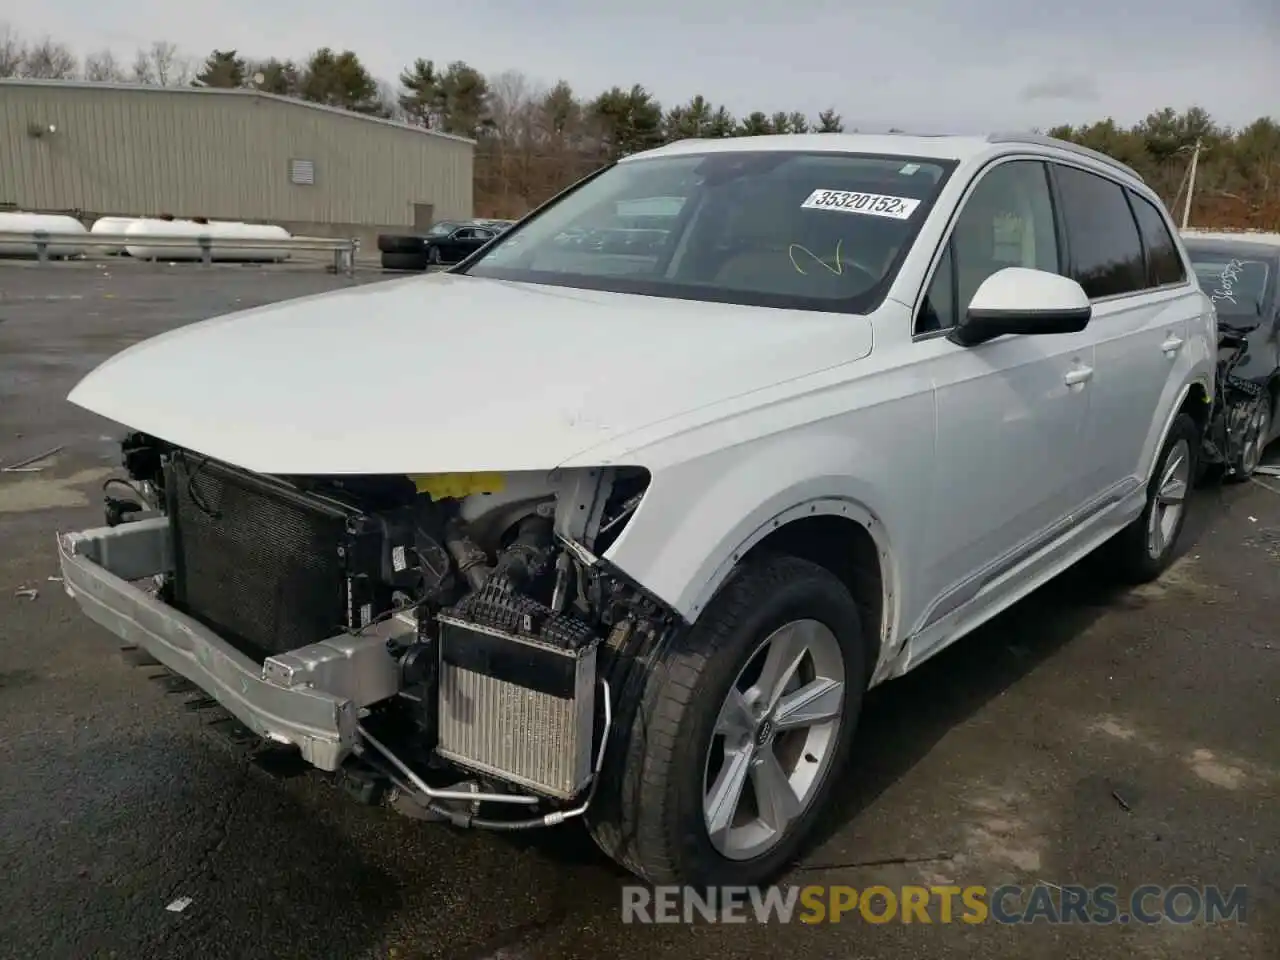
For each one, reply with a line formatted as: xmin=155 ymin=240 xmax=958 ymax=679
xmin=10 ymin=0 xmax=1280 ymax=133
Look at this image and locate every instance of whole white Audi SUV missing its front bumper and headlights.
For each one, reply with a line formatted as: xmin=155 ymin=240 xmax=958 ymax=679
xmin=58 ymin=134 xmax=1213 ymax=884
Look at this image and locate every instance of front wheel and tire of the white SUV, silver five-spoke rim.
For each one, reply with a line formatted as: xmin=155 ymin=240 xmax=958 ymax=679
xmin=588 ymin=557 xmax=867 ymax=886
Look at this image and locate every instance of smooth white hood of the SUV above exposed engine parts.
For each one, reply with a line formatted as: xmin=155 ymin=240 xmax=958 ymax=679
xmin=69 ymin=274 xmax=872 ymax=474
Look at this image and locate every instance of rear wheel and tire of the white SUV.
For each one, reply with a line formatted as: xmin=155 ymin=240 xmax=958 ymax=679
xmin=1103 ymin=413 xmax=1202 ymax=585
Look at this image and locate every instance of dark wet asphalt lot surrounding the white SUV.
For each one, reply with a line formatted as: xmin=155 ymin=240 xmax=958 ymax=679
xmin=0 ymin=262 xmax=1280 ymax=960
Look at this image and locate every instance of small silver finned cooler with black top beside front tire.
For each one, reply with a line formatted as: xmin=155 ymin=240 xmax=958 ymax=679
xmin=436 ymin=616 xmax=596 ymax=800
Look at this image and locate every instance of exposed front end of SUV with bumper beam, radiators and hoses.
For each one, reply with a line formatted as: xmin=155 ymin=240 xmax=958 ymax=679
xmin=59 ymin=434 xmax=678 ymax=829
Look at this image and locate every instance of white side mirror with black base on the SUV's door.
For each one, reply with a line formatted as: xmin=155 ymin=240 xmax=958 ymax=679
xmin=947 ymin=266 xmax=1093 ymax=347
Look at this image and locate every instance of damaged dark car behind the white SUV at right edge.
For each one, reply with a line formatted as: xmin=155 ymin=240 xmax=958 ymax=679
xmin=1183 ymin=234 xmax=1280 ymax=479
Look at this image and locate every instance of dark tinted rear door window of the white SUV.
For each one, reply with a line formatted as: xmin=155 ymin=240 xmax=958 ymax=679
xmin=1053 ymin=164 xmax=1148 ymax=300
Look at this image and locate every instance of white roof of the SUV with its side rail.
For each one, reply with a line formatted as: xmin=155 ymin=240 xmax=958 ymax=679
xmin=621 ymin=133 xmax=1146 ymax=184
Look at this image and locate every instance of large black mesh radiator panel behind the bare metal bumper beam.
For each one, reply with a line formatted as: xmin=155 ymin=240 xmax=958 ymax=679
xmin=169 ymin=458 xmax=347 ymax=658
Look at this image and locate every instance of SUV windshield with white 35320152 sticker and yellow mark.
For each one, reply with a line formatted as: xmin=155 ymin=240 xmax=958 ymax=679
xmin=461 ymin=151 xmax=955 ymax=312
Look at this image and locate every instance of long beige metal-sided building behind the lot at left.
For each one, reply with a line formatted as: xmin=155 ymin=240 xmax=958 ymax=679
xmin=0 ymin=81 xmax=475 ymax=232
